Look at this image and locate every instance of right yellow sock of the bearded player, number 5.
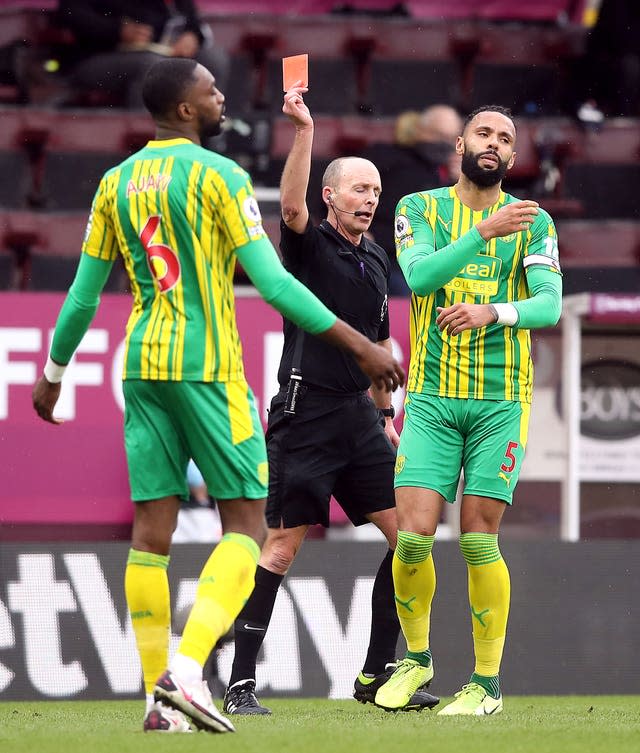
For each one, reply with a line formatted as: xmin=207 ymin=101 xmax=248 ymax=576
xmin=460 ymin=533 xmax=511 ymax=677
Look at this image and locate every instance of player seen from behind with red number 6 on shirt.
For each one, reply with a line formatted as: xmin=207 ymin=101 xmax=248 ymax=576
xmin=33 ymin=58 xmax=404 ymax=732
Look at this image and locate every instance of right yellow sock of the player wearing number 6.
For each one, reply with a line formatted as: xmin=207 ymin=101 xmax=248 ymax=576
xmin=178 ymin=533 xmax=260 ymax=666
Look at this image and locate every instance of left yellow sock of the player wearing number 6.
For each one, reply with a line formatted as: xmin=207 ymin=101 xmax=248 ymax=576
xmin=124 ymin=549 xmax=171 ymax=693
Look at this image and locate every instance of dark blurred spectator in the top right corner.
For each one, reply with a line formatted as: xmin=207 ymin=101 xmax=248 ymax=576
xmin=569 ymin=0 xmax=640 ymax=119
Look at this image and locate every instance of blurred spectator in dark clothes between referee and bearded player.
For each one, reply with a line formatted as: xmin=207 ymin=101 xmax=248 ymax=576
xmin=362 ymin=105 xmax=462 ymax=295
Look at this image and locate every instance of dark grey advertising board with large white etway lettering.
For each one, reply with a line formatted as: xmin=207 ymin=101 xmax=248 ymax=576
xmin=0 ymin=540 xmax=640 ymax=696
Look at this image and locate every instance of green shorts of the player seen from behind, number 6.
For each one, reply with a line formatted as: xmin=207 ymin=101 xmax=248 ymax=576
xmin=123 ymin=379 xmax=269 ymax=502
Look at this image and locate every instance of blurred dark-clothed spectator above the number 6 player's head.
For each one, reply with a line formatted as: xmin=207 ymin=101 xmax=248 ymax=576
xmin=58 ymin=0 xmax=229 ymax=109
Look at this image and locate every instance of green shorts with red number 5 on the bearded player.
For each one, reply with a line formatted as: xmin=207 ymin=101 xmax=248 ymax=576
xmin=394 ymin=393 xmax=531 ymax=504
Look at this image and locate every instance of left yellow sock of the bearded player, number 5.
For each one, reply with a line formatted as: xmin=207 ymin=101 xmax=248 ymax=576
xmin=392 ymin=531 xmax=436 ymax=653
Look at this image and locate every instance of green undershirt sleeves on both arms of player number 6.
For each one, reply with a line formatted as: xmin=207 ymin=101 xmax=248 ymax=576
xmin=51 ymin=239 xmax=337 ymax=365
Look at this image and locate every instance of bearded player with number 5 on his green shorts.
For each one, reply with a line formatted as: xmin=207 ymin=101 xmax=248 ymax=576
xmin=375 ymin=106 xmax=562 ymax=716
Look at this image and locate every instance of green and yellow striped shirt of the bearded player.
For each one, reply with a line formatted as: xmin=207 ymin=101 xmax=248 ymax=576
xmin=396 ymin=187 xmax=560 ymax=403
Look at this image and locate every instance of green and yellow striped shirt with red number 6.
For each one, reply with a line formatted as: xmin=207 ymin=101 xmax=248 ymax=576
xmin=82 ymin=138 xmax=266 ymax=382
